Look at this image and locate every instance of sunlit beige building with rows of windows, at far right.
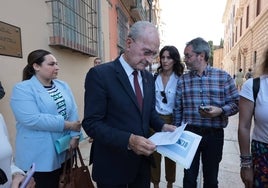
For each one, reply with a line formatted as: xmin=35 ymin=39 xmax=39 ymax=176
xmin=221 ymin=0 xmax=268 ymax=76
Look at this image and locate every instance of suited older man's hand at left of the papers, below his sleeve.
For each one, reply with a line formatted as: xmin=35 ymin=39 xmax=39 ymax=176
xmin=128 ymin=134 xmax=156 ymax=156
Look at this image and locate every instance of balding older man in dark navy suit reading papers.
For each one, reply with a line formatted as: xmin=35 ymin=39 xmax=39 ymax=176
xmin=82 ymin=21 xmax=176 ymax=188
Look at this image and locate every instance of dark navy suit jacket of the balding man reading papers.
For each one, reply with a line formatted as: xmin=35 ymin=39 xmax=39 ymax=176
xmin=82 ymin=58 xmax=164 ymax=184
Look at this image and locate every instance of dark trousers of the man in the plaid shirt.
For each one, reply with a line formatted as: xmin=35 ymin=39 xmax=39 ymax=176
xmin=183 ymin=125 xmax=224 ymax=188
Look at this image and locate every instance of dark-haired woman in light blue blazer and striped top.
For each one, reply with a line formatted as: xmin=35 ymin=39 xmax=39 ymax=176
xmin=10 ymin=50 xmax=81 ymax=188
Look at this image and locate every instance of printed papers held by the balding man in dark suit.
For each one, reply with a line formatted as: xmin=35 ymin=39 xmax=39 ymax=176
xmin=149 ymin=124 xmax=202 ymax=169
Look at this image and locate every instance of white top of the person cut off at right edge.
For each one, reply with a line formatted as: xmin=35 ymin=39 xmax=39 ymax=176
xmin=240 ymin=75 xmax=268 ymax=143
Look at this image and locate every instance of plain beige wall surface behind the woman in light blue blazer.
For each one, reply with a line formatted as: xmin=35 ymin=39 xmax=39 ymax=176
xmin=0 ymin=0 xmax=108 ymax=145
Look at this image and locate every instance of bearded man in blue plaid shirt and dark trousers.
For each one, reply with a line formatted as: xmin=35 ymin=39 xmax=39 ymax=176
xmin=174 ymin=38 xmax=239 ymax=188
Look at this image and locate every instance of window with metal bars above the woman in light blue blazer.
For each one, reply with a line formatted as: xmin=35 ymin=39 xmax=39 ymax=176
xmin=46 ymin=0 xmax=98 ymax=56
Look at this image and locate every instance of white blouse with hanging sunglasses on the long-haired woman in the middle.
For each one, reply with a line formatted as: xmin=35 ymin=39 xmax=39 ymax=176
xmin=155 ymin=72 xmax=179 ymax=115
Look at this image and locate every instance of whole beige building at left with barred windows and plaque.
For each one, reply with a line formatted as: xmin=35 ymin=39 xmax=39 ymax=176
xmin=0 ymin=0 xmax=159 ymax=146
